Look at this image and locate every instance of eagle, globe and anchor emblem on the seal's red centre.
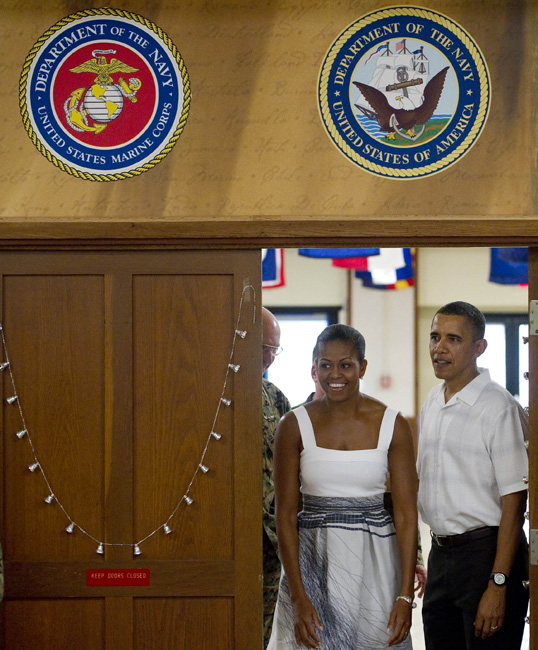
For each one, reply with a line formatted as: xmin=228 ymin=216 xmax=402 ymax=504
xmin=64 ymin=50 xmax=142 ymax=134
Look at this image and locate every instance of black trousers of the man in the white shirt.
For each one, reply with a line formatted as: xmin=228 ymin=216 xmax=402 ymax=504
xmin=422 ymin=532 xmax=529 ymax=650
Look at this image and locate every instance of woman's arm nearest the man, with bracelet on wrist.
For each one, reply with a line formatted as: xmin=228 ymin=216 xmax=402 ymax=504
xmin=388 ymin=415 xmax=418 ymax=645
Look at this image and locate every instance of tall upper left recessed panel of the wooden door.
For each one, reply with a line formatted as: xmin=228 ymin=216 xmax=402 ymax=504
xmin=3 ymin=275 xmax=104 ymax=562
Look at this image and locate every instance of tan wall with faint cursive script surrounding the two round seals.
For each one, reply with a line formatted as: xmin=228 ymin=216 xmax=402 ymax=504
xmin=0 ymin=0 xmax=538 ymax=246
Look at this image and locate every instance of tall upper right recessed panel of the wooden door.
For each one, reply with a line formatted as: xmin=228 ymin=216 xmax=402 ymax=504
xmin=133 ymin=276 xmax=233 ymax=559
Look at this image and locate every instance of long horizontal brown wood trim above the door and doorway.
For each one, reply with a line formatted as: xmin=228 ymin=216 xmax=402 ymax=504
xmin=0 ymin=215 xmax=538 ymax=250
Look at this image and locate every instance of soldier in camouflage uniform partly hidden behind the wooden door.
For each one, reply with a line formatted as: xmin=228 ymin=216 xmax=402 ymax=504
xmin=262 ymin=308 xmax=291 ymax=648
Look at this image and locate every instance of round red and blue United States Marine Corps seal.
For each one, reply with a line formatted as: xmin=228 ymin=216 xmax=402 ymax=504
xmin=19 ymin=7 xmax=191 ymax=181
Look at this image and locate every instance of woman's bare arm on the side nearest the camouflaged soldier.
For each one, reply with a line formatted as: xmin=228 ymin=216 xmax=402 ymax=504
xmin=274 ymin=413 xmax=321 ymax=648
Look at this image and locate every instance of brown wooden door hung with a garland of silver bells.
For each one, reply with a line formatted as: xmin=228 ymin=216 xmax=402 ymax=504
xmin=0 ymin=251 xmax=262 ymax=650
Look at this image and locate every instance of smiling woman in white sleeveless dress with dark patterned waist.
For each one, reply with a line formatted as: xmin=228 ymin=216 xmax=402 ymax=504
xmin=268 ymin=325 xmax=417 ymax=650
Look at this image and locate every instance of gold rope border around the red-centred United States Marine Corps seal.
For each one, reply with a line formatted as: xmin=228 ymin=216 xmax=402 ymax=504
xmin=19 ymin=7 xmax=191 ymax=181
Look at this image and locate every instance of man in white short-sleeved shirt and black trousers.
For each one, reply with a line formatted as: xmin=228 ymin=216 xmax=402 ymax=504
xmin=417 ymin=302 xmax=528 ymax=650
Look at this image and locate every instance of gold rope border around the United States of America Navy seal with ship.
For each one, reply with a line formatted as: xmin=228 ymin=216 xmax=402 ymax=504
xmin=319 ymin=7 xmax=491 ymax=180
